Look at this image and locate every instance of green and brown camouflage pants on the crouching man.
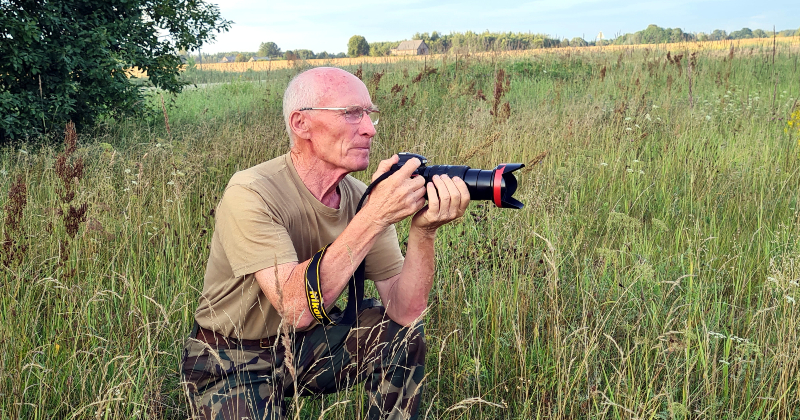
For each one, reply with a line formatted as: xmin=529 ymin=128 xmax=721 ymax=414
xmin=181 ymin=306 xmax=425 ymax=420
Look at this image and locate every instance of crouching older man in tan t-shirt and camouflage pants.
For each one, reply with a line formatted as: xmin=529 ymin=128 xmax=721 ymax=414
xmin=182 ymin=67 xmax=469 ymax=420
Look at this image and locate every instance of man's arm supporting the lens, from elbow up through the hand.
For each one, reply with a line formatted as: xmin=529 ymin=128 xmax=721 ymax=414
xmin=375 ymin=175 xmax=470 ymax=326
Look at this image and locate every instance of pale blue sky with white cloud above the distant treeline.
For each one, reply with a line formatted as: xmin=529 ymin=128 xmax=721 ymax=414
xmin=202 ymin=0 xmax=800 ymax=53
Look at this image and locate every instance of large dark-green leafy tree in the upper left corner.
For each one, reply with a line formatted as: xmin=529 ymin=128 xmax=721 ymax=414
xmin=0 ymin=0 xmax=232 ymax=142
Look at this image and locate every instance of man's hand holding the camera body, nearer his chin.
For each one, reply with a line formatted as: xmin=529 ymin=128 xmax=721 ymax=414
xmin=364 ymin=155 xmax=427 ymax=226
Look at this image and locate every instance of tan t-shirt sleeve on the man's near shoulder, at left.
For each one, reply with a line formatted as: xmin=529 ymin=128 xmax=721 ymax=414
xmin=215 ymin=185 xmax=297 ymax=277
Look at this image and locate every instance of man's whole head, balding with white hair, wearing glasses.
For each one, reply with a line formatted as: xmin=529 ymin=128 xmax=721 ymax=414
xmin=283 ymin=67 xmax=375 ymax=172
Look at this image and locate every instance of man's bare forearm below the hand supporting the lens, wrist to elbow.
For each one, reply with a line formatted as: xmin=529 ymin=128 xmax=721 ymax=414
xmin=384 ymin=227 xmax=436 ymax=325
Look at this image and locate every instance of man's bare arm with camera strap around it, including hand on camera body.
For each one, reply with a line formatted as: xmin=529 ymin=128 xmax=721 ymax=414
xmin=255 ymin=155 xmax=426 ymax=329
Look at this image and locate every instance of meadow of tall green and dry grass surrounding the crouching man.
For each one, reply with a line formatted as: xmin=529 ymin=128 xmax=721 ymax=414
xmin=0 ymin=37 xmax=800 ymax=419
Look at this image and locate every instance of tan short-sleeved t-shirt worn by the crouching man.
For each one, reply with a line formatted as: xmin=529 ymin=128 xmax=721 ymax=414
xmin=195 ymin=153 xmax=403 ymax=340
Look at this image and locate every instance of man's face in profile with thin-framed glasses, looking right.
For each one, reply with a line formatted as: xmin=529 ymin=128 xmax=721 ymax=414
xmin=308 ymin=74 xmax=375 ymax=172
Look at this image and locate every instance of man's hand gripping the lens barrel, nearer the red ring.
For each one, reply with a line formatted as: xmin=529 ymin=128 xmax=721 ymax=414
xmin=411 ymin=175 xmax=470 ymax=234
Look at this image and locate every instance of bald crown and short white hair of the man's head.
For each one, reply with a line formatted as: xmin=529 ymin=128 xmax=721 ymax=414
xmin=283 ymin=67 xmax=366 ymax=146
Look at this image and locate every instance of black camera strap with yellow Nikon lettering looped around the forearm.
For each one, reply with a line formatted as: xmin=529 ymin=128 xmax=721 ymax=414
xmin=306 ymin=171 xmax=392 ymax=325
